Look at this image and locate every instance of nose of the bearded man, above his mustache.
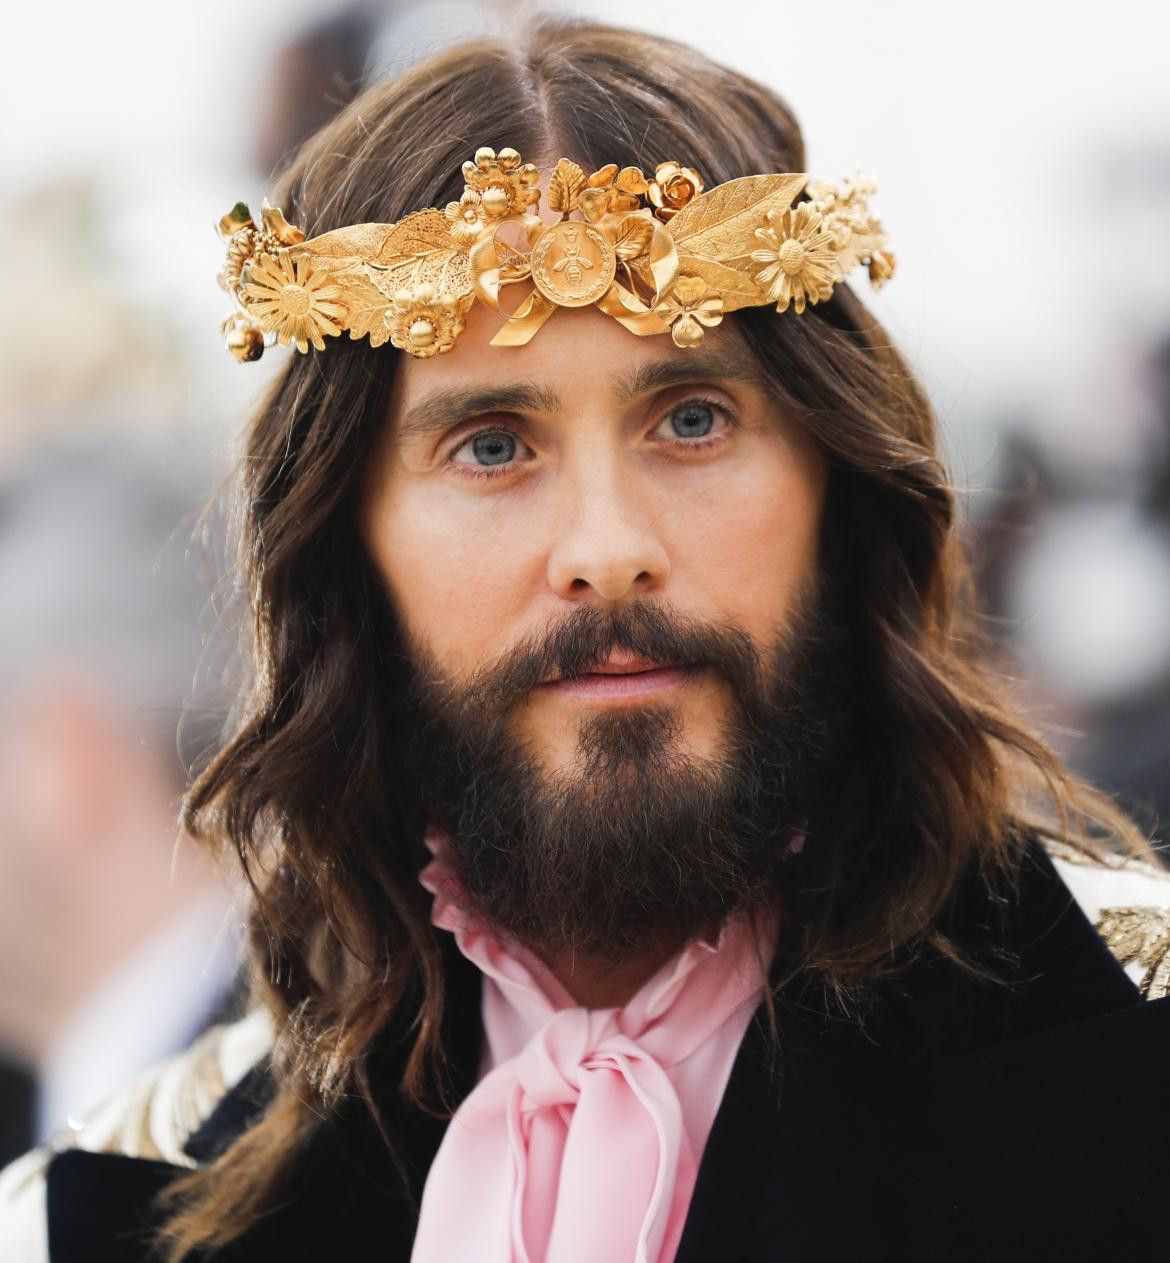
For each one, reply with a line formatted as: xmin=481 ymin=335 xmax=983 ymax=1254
xmin=548 ymin=457 xmax=670 ymax=602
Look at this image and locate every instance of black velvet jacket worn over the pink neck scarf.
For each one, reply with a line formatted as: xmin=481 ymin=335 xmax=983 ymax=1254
xmin=47 ymin=842 xmax=1170 ymax=1263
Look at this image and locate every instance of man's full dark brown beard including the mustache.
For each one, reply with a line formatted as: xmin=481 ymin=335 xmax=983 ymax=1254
xmin=394 ymin=595 xmax=836 ymax=964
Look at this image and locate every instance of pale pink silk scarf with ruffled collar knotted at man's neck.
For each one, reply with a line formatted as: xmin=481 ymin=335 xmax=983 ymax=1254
xmin=411 ymin=830 xmax=776 ymax=1263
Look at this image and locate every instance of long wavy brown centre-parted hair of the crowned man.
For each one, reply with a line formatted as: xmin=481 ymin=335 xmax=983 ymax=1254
xmin=155 ymin=16 xmax=1154 ymax=1263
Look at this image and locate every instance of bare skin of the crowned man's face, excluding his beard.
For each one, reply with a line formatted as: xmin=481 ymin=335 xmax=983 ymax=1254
xmin=360 ymin=303 xmax=828 ymax=1003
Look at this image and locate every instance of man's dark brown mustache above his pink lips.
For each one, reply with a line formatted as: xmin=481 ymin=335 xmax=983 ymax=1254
xmin=465 ymin=600 xmax=761 ymax=710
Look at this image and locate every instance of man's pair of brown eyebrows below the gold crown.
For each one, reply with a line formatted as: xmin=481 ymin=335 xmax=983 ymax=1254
xmin=394 ymin=347 xmax=763 ymax=443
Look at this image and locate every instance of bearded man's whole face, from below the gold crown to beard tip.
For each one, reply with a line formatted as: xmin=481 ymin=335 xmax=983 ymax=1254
xmin=361 ymin=304 xmax=833 ymax=955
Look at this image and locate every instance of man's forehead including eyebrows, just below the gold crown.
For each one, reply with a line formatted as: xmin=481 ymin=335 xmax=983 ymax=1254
xmin=389 ymin=302 xmax=766 ymax=441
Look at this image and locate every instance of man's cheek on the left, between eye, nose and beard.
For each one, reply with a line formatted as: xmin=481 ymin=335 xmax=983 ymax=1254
xmin=366 ymin=474 xmax=531 ymax=674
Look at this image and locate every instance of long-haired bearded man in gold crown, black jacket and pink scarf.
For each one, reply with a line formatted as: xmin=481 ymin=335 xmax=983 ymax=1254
xmin=5 ymin=12 xmax=1170 ymax=1263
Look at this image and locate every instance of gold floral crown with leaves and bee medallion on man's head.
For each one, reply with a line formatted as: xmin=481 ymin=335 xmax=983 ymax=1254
xmin=217 ymin=148 xmax=895 ymax=361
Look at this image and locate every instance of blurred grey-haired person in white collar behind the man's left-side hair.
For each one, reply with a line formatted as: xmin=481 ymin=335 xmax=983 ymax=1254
xmin=0 ymin=436 xmax=238 ymax=1163
